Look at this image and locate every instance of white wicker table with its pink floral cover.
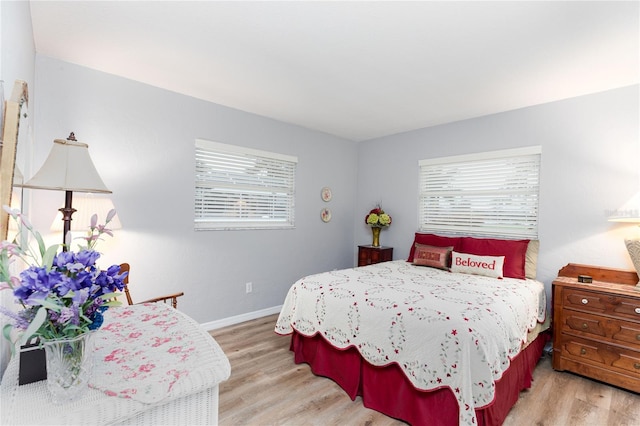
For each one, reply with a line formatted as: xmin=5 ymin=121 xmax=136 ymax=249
xmin=0 ymin=303 xmax=231 ymax=425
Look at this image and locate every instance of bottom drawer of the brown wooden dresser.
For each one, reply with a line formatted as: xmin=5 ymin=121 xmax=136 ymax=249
xmin=559 ymin=335 xmax=640 ymax=379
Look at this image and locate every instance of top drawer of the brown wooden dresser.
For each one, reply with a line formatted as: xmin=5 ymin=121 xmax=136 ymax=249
xmin=562 ymin=288 xmax=640 ymax=321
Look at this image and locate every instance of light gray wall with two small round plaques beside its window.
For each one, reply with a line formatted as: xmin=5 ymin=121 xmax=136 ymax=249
xmin=31 ymin=55 xmax=357 ymax=323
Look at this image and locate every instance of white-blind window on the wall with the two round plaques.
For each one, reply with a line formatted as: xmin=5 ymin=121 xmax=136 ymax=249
xmin=195 ymin=139 xmax=298 ymax=230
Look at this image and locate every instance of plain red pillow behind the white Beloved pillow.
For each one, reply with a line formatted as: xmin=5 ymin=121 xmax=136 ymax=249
xmin=456 ymin=237 xmax=529 ymax=280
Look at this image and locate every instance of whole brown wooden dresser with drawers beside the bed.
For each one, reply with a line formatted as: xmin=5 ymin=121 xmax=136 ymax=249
xmin=553 ymin=263 xmax=640 ymax=392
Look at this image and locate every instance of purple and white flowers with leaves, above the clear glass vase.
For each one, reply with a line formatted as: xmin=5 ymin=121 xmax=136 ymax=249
xmin=0 ymin=210 xmax=126 ymax=339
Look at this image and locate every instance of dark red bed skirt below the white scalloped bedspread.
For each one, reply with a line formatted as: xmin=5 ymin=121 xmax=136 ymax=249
xmin=290 ymin=332 xmax=549 ymax=426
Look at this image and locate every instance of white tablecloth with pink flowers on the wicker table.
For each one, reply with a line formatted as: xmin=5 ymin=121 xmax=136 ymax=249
xmin=89 ymin=303 xmax=230 ymax=403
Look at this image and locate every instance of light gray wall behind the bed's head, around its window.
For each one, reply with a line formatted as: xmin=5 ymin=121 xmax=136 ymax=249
xmin=355 ymin=86 xmax=640 ymax=302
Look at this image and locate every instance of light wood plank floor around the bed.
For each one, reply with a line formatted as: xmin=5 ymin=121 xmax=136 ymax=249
xmin=211 ymin=315 xmax=640 ymax=426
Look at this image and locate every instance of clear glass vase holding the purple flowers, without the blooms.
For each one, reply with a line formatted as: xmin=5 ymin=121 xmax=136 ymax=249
xmin=44 ymin=331 xmax=95 ymax=404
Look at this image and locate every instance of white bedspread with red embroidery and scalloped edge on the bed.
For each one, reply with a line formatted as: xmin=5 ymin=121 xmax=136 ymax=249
xmin=275 ymin=260 xmax=546 ymax=424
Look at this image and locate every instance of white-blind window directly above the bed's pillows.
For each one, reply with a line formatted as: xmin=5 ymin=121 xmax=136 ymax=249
xmin=418 ymin=146 xmax=541 ymax=239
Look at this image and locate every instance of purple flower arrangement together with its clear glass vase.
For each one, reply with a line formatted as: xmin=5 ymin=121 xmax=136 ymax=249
xmin=0 ymin=206 xmax=126 ymax=402
